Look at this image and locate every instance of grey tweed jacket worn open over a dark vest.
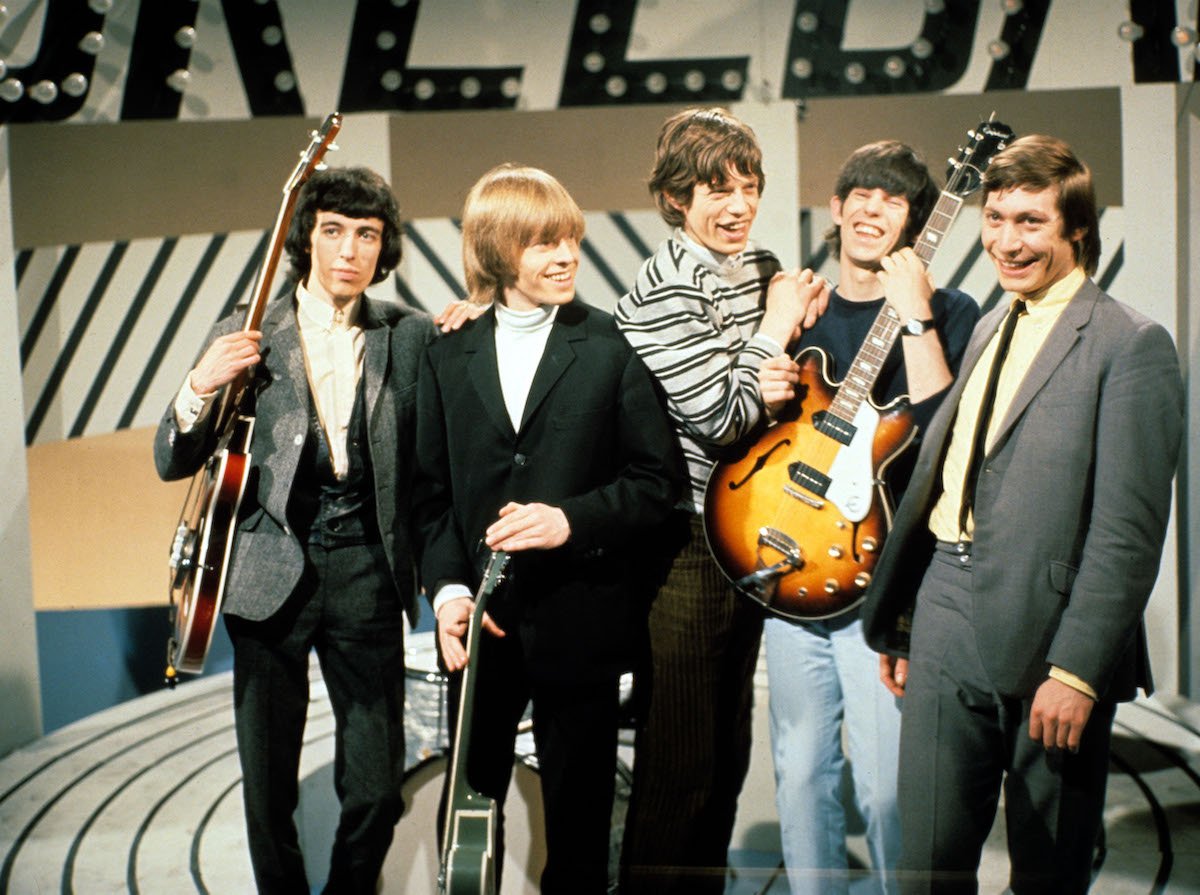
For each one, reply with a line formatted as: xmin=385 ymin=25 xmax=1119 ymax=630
xmin=154 ymin=295 xmax=434 ymax=624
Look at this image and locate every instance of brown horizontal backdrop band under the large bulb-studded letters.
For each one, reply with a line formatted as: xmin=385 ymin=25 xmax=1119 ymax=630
xmin=10 ymin=88 xmax=1122 ymax=248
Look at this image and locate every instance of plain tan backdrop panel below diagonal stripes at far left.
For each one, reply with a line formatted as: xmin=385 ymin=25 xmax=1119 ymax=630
xmin=26 ymin=428 xmax=187 ymax=609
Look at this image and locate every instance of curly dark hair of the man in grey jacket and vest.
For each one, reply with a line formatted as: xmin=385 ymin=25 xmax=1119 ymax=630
xmin=283 ymin=168 xmax=402 ymax=284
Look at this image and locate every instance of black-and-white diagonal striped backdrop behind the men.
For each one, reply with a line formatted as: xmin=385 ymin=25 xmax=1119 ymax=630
xmin=17 ymin=206 xmax=1132 ymax=444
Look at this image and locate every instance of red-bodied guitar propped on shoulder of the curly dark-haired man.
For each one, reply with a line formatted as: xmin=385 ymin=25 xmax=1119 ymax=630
xmin=166 ymin=112 xmax=342 ymax=686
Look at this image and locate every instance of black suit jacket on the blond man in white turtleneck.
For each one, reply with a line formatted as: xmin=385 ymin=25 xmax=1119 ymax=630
xmin=414 ymin=301 xmax=683 ymax=680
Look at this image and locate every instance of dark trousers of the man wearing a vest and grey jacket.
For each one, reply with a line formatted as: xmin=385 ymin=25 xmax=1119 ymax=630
xmin=226 ymin=545 xmax=404 ymax=895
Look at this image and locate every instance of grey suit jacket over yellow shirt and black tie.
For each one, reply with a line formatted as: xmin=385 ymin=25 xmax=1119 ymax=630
xmin=863 ymin=280 xmax=1183 ymax=699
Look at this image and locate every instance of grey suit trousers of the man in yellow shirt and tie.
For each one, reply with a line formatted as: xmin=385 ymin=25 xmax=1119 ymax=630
xmin=899 ymin=551 xmax=1115 ymax=895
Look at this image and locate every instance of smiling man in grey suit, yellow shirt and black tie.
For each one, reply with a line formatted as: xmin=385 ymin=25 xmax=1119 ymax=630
xmin=863 ymin=136 xmax=1183 ymax=894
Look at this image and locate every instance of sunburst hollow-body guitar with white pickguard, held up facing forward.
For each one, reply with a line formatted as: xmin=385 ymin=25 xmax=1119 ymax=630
xmin=704 ymin=120 xmax=1013 ymax=620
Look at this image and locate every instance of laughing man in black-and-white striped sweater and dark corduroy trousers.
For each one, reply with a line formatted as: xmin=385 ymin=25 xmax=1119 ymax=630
xmin=617 ymin=109 xmax=828 ymax=895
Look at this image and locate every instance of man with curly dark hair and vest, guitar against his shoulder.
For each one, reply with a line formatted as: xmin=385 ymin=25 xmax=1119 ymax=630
xmin=155 ymin=168 xmax=433 ymax=893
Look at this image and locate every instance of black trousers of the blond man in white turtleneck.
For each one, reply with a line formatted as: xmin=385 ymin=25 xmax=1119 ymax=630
xmin=438 ymin=630 xmax=619 ymax=895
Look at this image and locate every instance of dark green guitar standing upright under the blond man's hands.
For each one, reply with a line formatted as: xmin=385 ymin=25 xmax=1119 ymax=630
xmin=438 ymin=551 xmax=509 ymax=895
